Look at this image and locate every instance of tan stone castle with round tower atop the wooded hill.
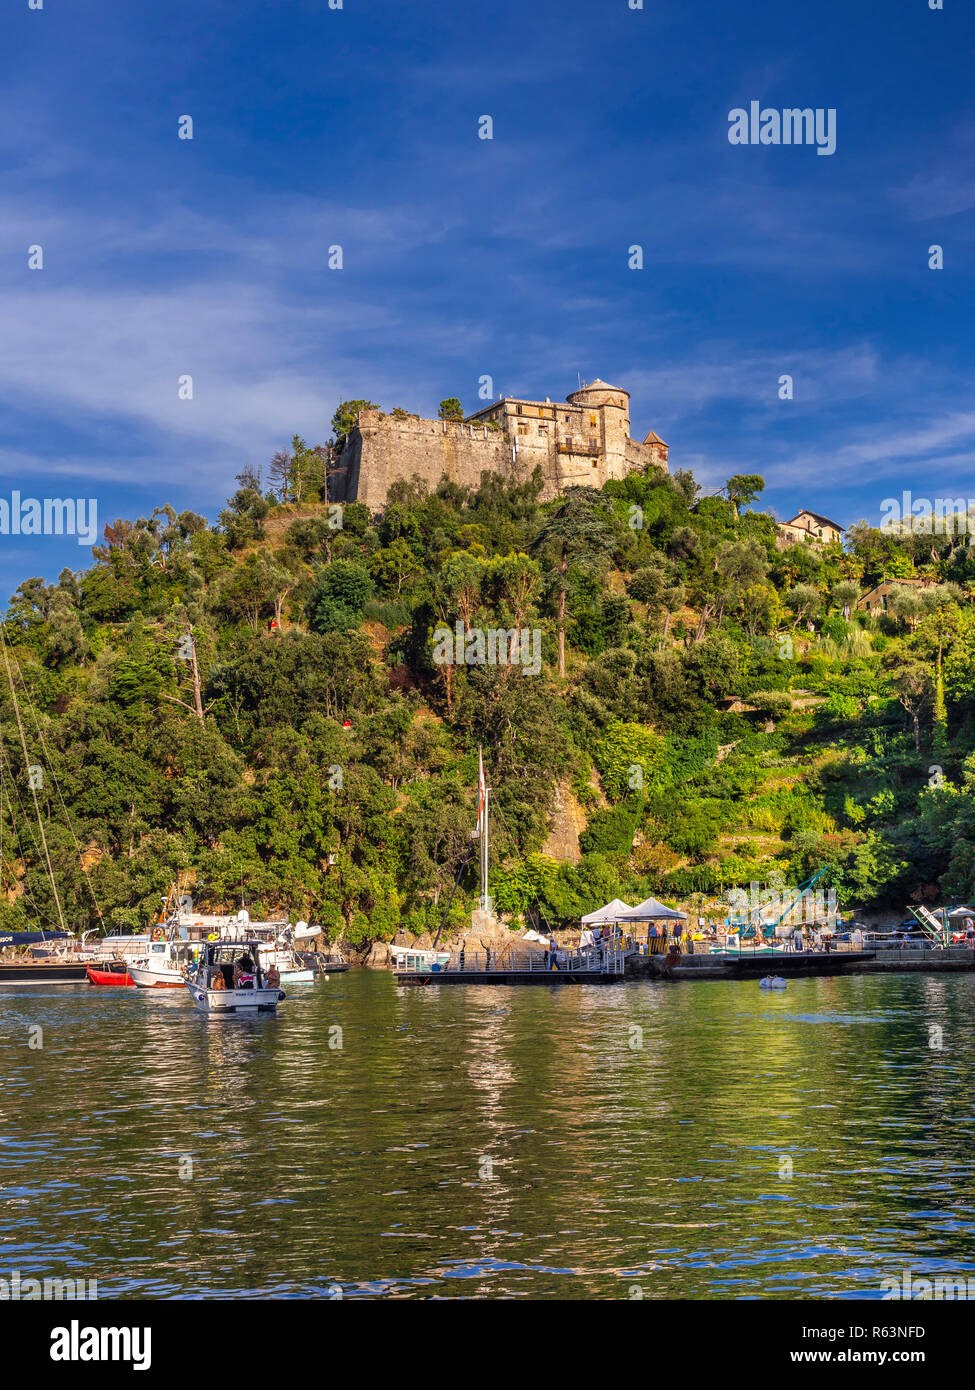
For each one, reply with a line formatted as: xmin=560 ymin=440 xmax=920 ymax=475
xmin=328 ymin=379 xmax=668 ymax=512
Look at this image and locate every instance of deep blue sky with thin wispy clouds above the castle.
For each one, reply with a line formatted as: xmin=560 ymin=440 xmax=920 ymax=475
xmin=0 ymin=0 xmax=975 ymax=592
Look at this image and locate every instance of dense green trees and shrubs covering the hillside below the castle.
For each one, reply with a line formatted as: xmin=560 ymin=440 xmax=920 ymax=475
xmin=0 ymin=414 xmax=975 ymax=942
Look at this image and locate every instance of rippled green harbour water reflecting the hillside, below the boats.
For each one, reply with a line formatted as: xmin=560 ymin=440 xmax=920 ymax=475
xmin=0 ymin=972 xmax=975 ymax=1298
